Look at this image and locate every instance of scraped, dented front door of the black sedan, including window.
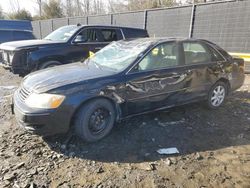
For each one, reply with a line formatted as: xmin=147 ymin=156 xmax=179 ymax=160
xmin=122 ymin=42 xmax=189 ymax=115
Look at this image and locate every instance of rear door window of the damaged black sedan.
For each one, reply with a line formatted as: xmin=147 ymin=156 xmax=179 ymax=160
xmin=183 ymin=42 xmax=213 ymax=64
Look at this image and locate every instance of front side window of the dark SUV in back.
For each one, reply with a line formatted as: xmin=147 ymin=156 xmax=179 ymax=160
xmin=74 ymin=29 xmax=98 ymax=43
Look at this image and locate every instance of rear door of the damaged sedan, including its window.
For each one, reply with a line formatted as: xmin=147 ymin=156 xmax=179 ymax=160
xmin=179 ymin=41 xmax=225 ymax=100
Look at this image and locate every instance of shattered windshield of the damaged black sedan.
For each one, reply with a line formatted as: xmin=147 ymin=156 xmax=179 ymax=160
xmin=86 ymin=40 xmax=152 ymax=72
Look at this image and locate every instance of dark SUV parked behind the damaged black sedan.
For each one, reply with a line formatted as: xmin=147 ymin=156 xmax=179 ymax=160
xmin=0 ymin=25 xmax=148 ymax=75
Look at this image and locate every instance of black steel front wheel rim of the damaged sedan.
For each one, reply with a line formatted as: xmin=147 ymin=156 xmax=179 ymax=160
xmin=89 ymin=108 xmax=111 ymax=134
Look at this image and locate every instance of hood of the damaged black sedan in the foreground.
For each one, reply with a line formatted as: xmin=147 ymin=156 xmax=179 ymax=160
xmin=22 ymin=63 xmax=114 ymax=93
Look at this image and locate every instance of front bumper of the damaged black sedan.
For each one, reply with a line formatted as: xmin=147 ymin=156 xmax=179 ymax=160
xmin=12 ymin=91 xmax=71 ymax=136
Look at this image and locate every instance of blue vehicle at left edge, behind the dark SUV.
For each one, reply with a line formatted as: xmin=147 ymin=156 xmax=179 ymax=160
xmin=0 ymin=20 xmax=35 ymax=62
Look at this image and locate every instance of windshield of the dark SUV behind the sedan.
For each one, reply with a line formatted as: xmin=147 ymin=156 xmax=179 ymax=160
xmin=44 ymin=25 xmax=78 ymax=41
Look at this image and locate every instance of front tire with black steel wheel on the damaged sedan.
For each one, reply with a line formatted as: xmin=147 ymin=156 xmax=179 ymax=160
xmin=74 ymin=99 xmax=116 ymax=142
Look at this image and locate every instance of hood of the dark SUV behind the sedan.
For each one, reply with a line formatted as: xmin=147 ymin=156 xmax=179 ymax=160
xmin=0 ymin=40 xmax=64 ymax=51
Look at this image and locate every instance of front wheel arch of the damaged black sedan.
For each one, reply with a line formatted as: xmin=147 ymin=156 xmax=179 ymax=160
xmin=70 ymin=96 xmax=121 ymax=127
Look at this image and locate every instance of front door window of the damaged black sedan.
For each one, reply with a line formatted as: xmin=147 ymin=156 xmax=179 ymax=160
xmin=134 ymin=42 xmax=178 ymax=72
